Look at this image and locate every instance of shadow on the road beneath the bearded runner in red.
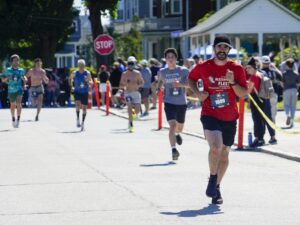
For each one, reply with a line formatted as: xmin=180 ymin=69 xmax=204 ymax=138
xmin=160 ymin=204 xmax=224 ymax=217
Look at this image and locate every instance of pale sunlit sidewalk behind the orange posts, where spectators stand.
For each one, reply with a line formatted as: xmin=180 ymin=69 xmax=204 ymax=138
xmin=105 ymin=103 xmax=300 ymax=162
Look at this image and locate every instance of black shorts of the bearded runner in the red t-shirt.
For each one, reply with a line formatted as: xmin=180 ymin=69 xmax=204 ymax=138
xmin=201 ymin=116 xmax=236 ymax=146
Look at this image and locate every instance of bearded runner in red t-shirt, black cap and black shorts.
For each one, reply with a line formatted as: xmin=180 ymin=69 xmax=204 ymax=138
xmin=188 ymin=36 xmax=248 ymax=204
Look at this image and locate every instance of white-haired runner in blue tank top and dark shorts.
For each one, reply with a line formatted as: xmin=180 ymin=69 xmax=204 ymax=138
xmin=69 ymin=59 xmax=93 ymax=131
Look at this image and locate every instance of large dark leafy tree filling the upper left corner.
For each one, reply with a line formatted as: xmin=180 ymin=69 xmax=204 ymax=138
xmin=0 ymin=0 xmax=78 ymax=66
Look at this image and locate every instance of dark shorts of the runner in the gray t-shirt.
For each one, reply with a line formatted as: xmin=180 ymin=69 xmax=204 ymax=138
xmin=165 ymin=103 xmax=187 ymax=123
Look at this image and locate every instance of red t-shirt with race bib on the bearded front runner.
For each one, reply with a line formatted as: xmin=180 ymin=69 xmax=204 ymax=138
xmin=189 ymin=59 xmax=247 ymax=121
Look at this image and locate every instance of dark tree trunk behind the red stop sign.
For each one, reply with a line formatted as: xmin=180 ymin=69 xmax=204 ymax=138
xmin=89 ymin=1 xmax=108 ymax=69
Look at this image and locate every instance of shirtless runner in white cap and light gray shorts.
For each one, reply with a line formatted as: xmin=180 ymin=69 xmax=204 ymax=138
xmin=120 ymin=56 xmax=144 ymax=133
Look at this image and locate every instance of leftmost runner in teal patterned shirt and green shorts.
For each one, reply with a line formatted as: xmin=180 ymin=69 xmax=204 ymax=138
xmin=2 ymin=54 xmax=26 ymax=128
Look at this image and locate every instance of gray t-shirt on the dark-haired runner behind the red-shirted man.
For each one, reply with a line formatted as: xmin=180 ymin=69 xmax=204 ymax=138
xmin=158 ymin=66 xmax=189 ymax=105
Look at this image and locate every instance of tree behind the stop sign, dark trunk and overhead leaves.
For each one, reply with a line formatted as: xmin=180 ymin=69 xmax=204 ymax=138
xmin=85 ymin=0 xmax=119 ymax=67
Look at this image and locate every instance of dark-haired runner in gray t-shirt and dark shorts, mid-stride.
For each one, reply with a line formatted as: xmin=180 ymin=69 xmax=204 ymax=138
xmin=158 ymin=48 xmax=189 ymax=160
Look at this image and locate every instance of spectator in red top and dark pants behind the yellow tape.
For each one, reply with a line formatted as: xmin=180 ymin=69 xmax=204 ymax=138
xmin=245 ymin=57 xmax=277 ymax=144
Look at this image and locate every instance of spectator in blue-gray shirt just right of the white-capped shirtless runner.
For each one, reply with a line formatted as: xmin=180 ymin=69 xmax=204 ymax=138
xmin=140 ymin=59 xmax=152 ymax=116
